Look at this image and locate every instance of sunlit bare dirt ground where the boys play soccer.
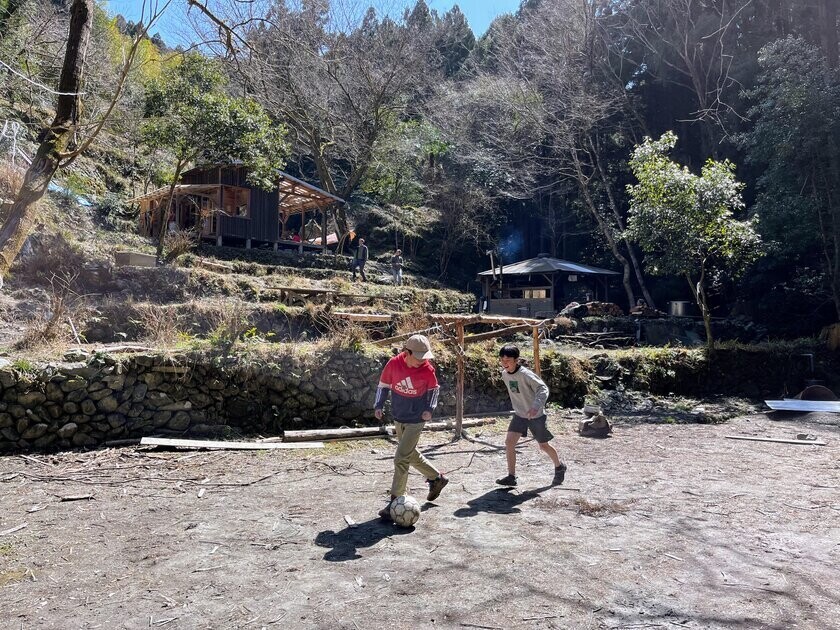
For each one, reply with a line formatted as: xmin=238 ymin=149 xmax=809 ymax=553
xmin=0 ymin=413 xmax=840 ymax=630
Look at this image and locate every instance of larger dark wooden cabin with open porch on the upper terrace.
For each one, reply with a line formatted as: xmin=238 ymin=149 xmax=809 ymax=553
xmin=132 ymin=165 xmax=344 ymax=252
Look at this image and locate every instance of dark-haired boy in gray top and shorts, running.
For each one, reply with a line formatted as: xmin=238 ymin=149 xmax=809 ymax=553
xmin=496 ymin=345 xmax=566 ymax=487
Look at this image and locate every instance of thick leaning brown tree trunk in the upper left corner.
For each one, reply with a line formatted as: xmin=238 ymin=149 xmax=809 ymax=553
xmin=0 ymin=0 xmax=93 ymax=286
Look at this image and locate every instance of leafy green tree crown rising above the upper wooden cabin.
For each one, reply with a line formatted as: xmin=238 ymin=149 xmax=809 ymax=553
xmin=143 ymin=54 xmax=289 ymax=189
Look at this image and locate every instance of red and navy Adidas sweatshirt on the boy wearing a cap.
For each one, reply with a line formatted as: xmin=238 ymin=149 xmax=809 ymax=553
xmin=373 ymin=352 xmax=440 ymax=424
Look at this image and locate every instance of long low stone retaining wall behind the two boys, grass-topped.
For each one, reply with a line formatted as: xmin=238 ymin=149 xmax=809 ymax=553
xmin=0 ymin=344 xmax=840 ymax=452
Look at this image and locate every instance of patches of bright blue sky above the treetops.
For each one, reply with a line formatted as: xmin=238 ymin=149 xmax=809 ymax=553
xmin=102 ymin=0 xmax=520 ymax=46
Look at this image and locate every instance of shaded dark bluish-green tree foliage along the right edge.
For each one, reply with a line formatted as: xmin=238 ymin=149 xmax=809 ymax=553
xmin=740 ymin=37 xmax=840 ymax=313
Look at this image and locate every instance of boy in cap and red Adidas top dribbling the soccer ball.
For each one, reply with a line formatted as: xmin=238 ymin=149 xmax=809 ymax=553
xmin=373 ymin=335 xmax=449 ymax=520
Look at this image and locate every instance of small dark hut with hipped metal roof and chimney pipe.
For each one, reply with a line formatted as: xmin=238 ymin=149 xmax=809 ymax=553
xmin=478 ymin=254 xmax=621 ymax=317
